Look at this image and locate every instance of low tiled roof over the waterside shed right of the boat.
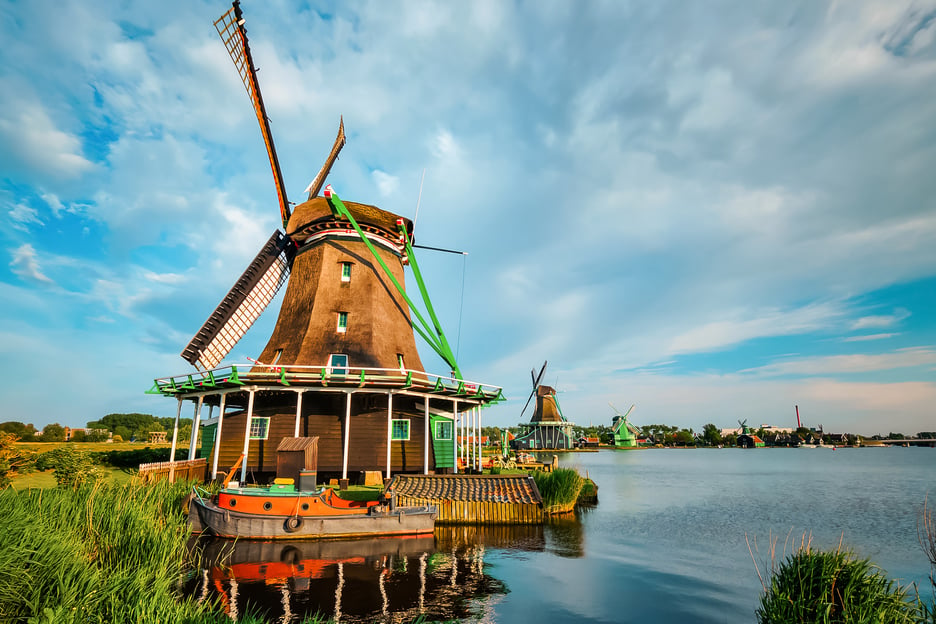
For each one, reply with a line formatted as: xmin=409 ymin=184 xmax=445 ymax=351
xmin=390 ymin=474 xmax=543 ymax=504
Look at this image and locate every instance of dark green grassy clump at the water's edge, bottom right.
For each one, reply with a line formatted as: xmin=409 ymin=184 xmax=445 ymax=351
xmin=756 ymin=539 xmax=921 ymax=624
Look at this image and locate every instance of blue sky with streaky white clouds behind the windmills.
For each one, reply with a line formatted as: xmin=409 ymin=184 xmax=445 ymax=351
xmin=0 ymin=0 xmax=936 ymax=435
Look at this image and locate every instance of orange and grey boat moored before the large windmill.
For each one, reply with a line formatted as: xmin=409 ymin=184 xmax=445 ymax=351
xmin=189 ymin=479 xmax=438 ymax=540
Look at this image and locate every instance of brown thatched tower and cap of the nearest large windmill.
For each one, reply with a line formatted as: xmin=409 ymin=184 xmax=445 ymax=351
xmin=259 ymin=197 xmax=423 ymax=371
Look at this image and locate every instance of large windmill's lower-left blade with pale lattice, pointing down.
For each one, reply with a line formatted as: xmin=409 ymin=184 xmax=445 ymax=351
xmin=182 ymin=230 xmax=296 ymax=370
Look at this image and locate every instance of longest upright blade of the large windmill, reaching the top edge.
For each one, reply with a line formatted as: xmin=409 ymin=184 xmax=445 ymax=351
xmin=215 ymin=0 xmax=290 ymax=228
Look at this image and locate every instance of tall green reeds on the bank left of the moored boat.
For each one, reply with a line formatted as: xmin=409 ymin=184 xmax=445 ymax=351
xmin=0 ymin=481 xmax=226 ymax=624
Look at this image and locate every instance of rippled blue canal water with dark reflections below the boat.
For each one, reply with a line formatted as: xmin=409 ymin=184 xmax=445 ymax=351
xmin=186 ymin=448 xmax=936 ymax=624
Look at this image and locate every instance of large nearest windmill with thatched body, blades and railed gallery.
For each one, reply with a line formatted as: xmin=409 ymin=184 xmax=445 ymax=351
xmin=151 ymin=0 xmax=503 ymax=480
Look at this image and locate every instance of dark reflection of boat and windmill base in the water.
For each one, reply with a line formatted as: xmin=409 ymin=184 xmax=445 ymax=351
xmin=184 ymin=517 xmax=583 ymax=623
